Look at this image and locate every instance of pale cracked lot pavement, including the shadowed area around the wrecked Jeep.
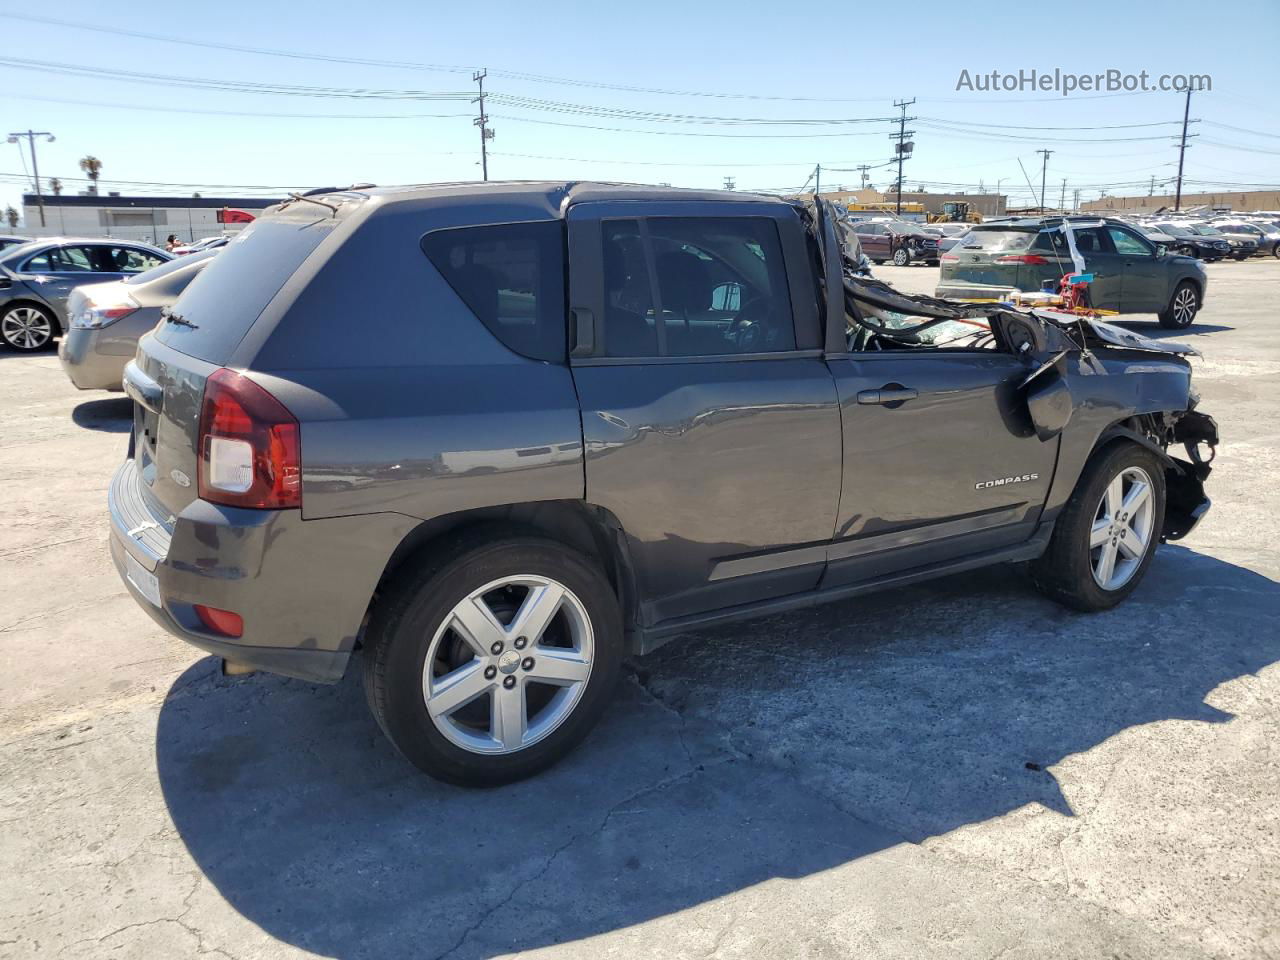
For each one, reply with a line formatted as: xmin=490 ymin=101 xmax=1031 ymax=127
xmin=0 ymin=260 xmax=1280 ymax=960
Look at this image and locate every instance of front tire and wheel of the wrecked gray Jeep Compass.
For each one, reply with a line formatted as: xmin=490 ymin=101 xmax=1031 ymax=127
xmin=1030 ymin=440 xmax=1165 ymax=611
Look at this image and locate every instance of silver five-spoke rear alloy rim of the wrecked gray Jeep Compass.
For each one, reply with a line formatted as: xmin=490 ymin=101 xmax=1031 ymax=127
xmin=422 ymin=575 xmax=595 ymax=754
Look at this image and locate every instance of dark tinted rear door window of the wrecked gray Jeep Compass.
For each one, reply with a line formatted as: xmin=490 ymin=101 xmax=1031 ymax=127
xmin=604 ymin=218 xmax=795 ymax=357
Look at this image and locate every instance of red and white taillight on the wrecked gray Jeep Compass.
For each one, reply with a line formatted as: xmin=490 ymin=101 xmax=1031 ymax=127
xmin=198 ymin=367 xmax=302 ymax=509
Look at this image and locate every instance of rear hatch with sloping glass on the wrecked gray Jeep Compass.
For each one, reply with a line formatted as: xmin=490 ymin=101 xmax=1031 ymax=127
xmin=124 ymin=216 xmax=340 ymax=525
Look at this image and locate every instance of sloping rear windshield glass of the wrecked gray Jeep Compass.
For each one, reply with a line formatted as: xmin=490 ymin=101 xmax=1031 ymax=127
xmin=156 ymin=218 xmax=338 ymax=364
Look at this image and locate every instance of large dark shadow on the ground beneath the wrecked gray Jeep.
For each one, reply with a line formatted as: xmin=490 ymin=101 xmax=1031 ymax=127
xmin=156 ymin=547 xmax=1280 ymax=957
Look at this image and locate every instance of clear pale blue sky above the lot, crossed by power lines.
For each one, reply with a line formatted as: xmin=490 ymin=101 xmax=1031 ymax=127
xmin=0 ymin=0 xmax=1280 ymax=218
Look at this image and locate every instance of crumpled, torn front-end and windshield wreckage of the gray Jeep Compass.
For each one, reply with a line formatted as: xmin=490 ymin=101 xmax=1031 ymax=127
xmin=792 ymin=196 xmax=1219 ymax=540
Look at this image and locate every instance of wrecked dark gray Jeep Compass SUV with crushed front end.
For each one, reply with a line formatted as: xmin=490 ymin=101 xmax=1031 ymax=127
xmin=109 ymin=183 xmax=1217 ymax=785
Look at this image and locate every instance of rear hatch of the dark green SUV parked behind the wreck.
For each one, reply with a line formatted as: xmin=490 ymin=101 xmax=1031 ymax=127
xmin=941 ymin=224 xmax=1071 ymax=291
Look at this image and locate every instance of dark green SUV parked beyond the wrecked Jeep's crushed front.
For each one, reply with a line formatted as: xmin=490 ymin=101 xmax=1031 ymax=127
xmin=937 ymin=216 xmax=1207 ymax=329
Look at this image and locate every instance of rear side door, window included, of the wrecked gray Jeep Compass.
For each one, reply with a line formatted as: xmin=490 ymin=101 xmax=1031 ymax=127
xmin=568 ymin=201 xmax=841 ymax=623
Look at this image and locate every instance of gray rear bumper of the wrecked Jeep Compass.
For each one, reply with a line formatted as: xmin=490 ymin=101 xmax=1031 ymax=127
xmin=108 ymin=460 xmax=417 ymax=682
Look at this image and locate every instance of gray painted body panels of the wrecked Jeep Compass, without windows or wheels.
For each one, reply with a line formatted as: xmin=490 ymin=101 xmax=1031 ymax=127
xmin=110 ymin=183 xmax=1208 ymax=680
